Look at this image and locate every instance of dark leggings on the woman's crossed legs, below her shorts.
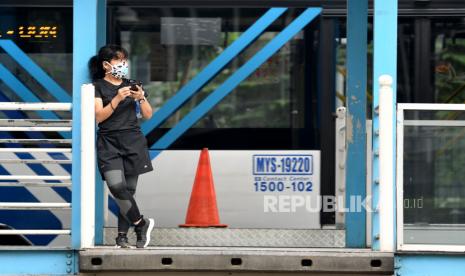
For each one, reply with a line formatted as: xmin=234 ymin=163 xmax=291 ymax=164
xmin=103 ymin=170 xmax=141 ymax=233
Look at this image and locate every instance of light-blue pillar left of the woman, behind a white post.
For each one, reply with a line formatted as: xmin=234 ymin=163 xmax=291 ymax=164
xmin=71 ymin=0 xmax=97 ymax=249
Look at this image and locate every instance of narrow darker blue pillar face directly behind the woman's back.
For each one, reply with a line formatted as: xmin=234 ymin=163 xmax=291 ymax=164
xmin=95 ymin=0 xmax=108 ymax=245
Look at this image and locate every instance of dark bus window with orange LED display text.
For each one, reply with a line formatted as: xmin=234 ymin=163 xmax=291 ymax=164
xmin=0 ymin=7 xmax=73 ymax=118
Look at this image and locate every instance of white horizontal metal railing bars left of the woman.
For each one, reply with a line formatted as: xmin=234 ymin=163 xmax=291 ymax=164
xmin=0 ymin=102 xmax=72 ymax=235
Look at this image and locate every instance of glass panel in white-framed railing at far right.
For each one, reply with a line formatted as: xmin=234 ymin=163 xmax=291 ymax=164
xmin=403 ymin=111 xmax=465 ymax=245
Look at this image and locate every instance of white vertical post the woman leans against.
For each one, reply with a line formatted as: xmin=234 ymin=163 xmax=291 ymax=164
xmin=81 ymin=84 xmax=95 ymax=248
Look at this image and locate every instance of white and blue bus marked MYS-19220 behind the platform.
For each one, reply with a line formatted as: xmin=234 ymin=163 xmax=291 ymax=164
xmin=0 ymin=0 xmax=465 ymax=247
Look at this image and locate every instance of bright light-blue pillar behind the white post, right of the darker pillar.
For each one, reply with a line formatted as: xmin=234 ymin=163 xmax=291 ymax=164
xmin=372 ymin=0 xmax=397 ymax=250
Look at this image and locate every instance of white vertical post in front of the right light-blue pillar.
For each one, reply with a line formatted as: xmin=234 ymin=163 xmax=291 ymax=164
xmin=376 ymin=75 xmax=394 ymax=251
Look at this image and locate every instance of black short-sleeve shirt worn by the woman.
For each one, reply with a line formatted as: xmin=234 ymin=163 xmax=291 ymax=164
xmin=93 ymin=79 xmax=140 ymax=133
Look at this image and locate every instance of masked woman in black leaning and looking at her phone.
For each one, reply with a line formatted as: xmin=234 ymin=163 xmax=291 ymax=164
xmin=89 ymin=45 xmax=154 ymax=248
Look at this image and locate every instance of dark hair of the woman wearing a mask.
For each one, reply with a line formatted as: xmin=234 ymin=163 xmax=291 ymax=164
xmin=88 ymin=44 xmax=128 ymax=81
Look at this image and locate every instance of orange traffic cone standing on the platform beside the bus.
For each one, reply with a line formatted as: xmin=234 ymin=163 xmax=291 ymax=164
xmin=179 ymin=148 xmax=227 ymax=227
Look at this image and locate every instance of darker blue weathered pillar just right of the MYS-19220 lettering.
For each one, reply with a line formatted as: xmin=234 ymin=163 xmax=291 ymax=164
xmin=345 ymin=0 xmax=368 ymax=248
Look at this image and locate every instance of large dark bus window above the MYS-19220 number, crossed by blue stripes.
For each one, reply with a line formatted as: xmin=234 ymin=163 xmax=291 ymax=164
xmin=109 ymin=6 xmax=318 ymax=149
